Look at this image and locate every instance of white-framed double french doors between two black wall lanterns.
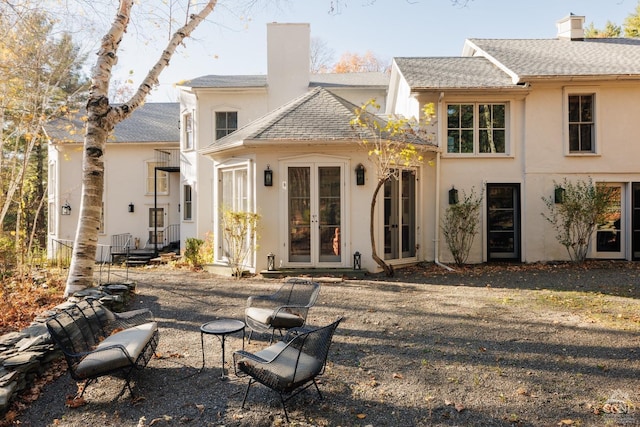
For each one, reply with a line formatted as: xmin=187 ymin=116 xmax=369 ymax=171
xmin=287 ymin=163 xmax=345 ymax=266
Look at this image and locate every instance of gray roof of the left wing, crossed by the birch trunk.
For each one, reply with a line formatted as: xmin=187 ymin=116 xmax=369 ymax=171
xmin=45 ymin=102 xmax=180 ymax=143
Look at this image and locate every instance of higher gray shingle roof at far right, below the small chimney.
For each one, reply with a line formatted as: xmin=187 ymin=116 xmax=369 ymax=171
xmin=467 ymin=38 xmax=640 ymax=81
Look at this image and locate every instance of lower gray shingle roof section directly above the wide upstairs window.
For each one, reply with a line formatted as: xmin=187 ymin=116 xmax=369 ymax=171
xmin=394 ymin=57 xmax=515 ymax=89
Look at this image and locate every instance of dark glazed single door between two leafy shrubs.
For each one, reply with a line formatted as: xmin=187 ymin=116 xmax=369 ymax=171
xmin=487 ymin=184 xmax=520 ymax=261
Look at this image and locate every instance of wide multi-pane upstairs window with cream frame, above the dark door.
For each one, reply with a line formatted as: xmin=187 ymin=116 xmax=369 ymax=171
xmin=447 ymin=103 xmax=507 ymax=154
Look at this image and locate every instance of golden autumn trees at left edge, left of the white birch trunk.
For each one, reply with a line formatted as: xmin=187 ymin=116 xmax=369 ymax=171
xmin=0 ymin=2 xmax=88 ymax=270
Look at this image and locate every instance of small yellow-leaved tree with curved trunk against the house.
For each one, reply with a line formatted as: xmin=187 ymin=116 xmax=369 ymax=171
xmin=351 ymin=100 xmax=435 ymax=276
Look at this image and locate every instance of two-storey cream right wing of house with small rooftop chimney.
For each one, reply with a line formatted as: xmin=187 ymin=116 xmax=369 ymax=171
xmin=387 ymin=15 xmax=640 ymax=263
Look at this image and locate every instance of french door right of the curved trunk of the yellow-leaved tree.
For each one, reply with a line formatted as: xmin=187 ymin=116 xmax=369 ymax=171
xmin=384 ymin=170 xmax=416 ymax=260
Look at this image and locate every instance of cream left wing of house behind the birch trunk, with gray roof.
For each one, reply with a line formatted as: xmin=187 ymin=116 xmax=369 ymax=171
xmin=45 ymin=102 xmax=181 ymax=261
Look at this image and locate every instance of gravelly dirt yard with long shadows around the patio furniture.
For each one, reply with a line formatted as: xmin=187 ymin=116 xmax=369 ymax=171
xmin=13 ymin=262 xmax=640 ymax=427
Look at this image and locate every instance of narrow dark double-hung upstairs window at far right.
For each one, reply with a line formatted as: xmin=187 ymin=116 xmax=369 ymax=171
xmin=569 ymin=94 xmax=595 ymax=153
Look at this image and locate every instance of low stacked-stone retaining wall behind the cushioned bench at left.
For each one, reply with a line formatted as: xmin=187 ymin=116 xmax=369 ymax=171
xmin=0 ymin=282 xmax=135 ymax=414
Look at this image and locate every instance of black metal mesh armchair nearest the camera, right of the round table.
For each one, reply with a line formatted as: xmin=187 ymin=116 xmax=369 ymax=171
xmin=233 ymin=317 xmax=342 ymax=422
